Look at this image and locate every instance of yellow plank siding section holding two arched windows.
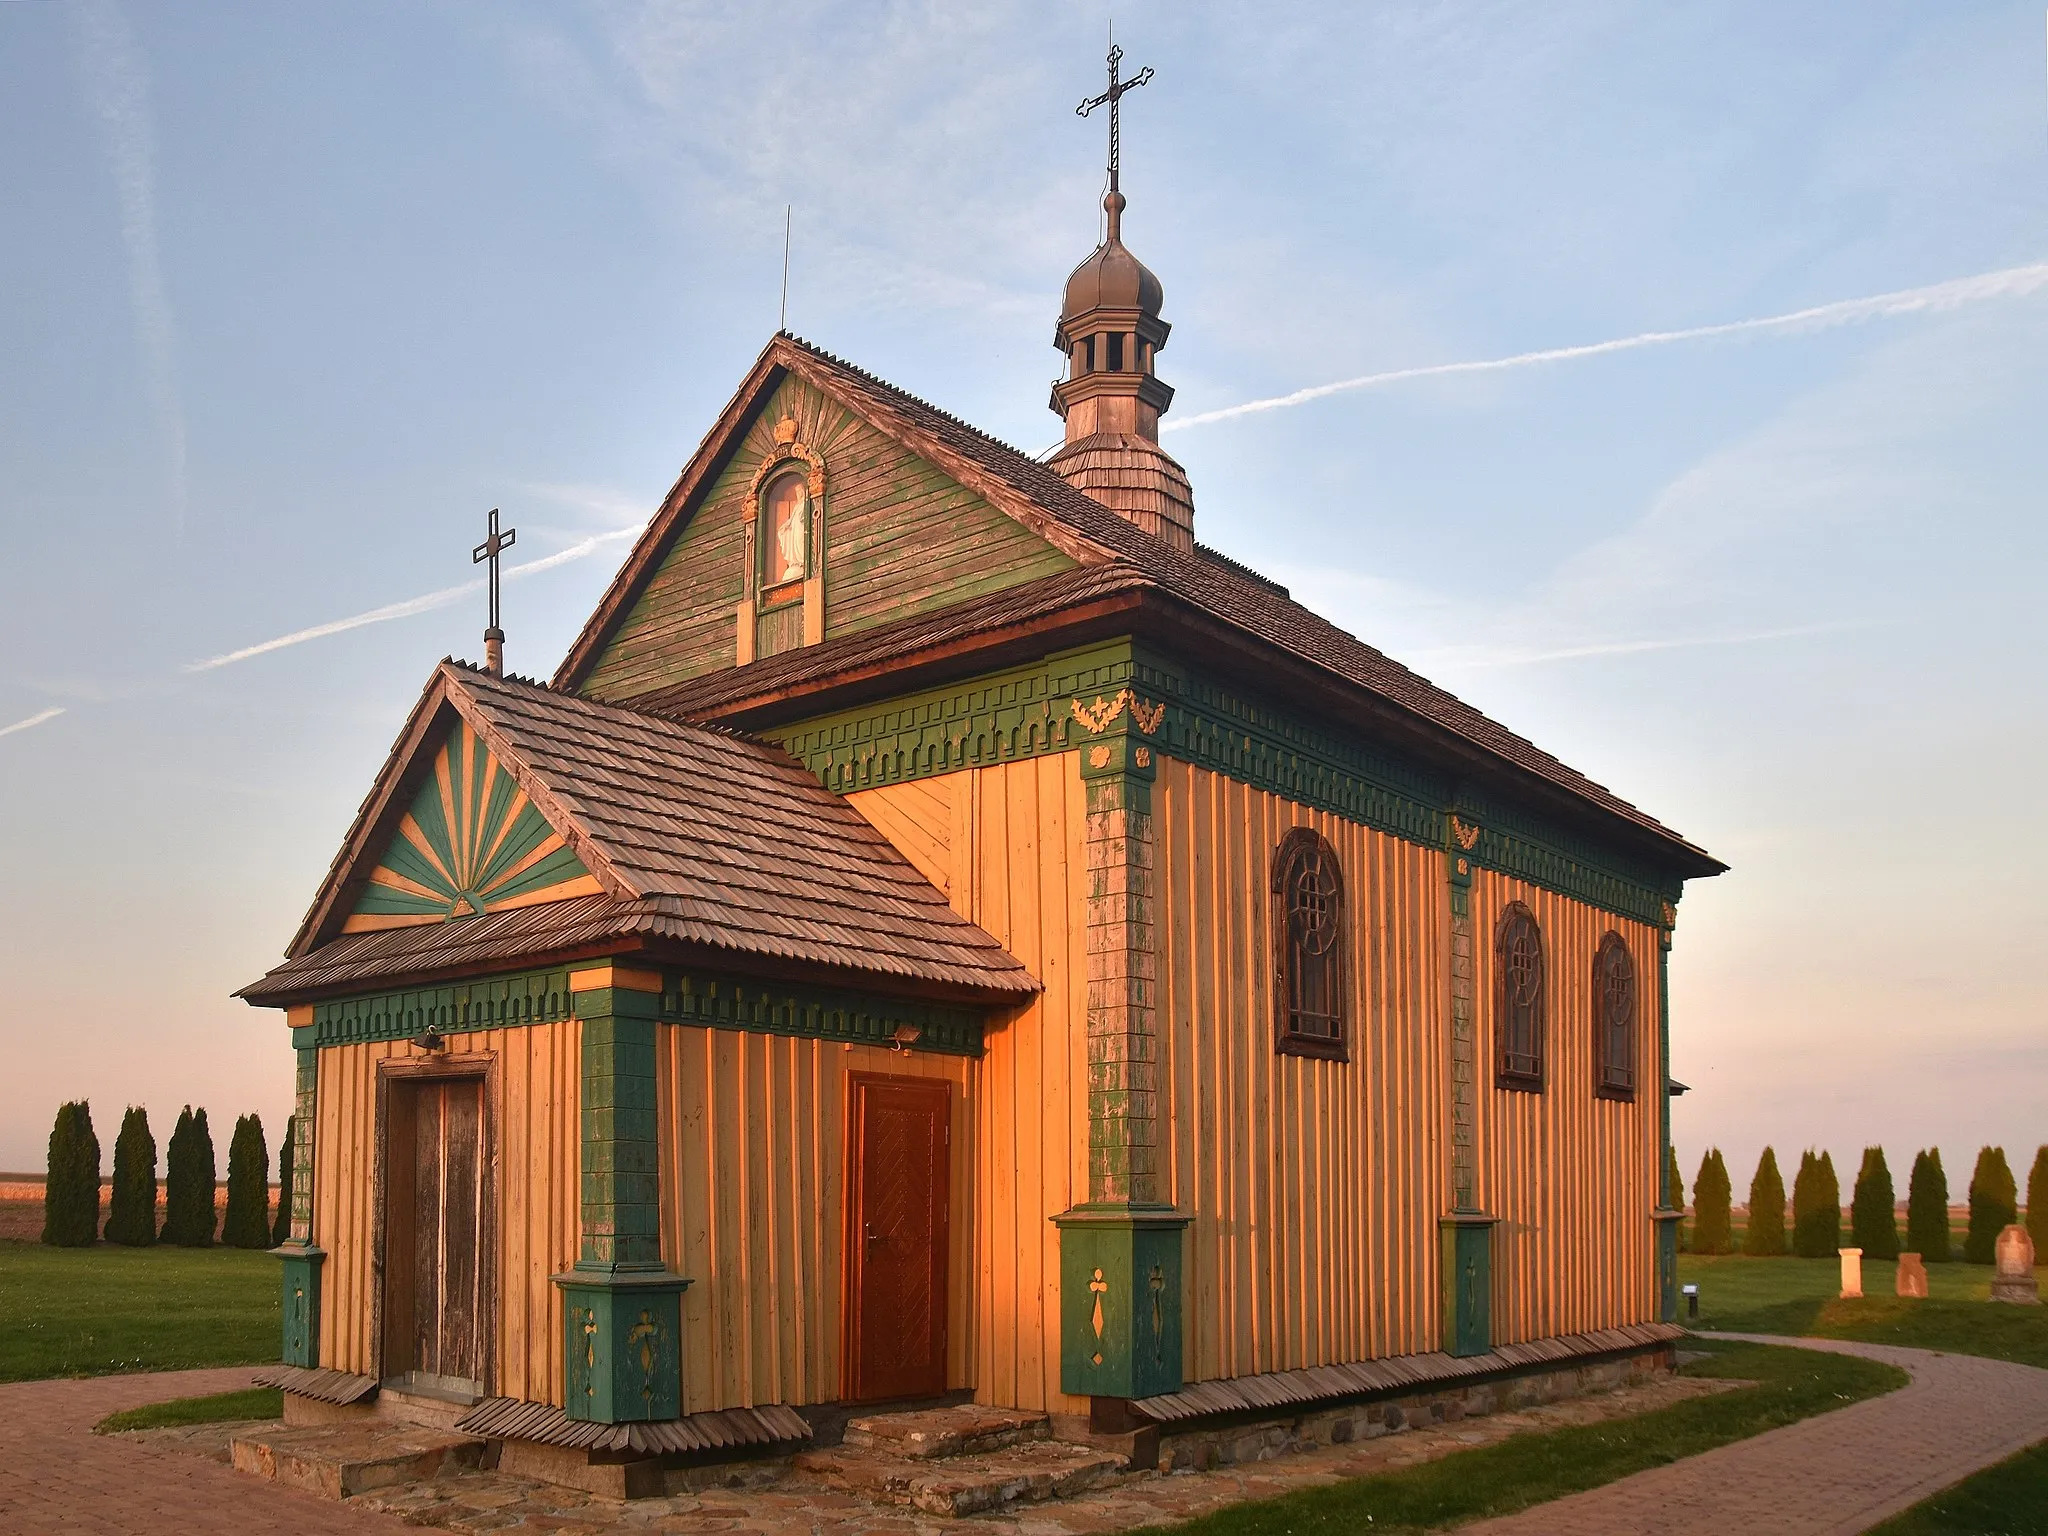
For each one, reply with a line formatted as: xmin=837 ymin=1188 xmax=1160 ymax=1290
xmin=1473 ymin=870 xmax=1663 ymax=1343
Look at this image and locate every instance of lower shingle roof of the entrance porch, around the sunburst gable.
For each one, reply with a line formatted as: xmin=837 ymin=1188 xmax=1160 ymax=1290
xmin=240 ymin=662 xmax=1038 ymax=1004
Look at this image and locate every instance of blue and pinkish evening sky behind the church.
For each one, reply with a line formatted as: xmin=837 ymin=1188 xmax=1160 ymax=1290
xmin=0 ymin=0 xmax=2048 ymax=1196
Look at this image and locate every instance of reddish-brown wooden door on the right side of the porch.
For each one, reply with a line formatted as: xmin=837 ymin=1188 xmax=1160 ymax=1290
xmin=846 ymin=1075 xmax=952 ymax=1403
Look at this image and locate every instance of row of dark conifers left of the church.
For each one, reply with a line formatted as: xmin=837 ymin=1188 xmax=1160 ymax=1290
xmin=43 ymin=1100 xmax=293 ymax=1247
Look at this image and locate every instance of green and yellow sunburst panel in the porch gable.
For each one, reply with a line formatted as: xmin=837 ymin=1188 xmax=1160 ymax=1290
xmin=342 ymin=721 xmax=604 ymax=934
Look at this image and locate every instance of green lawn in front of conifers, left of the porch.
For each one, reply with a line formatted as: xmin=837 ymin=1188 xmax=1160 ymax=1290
xmin=0 ymin=1243 xmax=281 ymax=1380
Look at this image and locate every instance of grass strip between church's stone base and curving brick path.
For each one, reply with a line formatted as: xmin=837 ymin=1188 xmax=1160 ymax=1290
xmin=1153 ymin=1343 xmax=1907 ymax=1536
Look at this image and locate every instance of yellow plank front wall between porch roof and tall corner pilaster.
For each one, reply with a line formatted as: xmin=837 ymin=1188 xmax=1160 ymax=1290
xmin=848 ymin=752 xmax=1087 ymax=1413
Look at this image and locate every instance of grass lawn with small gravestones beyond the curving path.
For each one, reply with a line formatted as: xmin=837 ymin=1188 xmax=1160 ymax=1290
xmin=1677 ymin=1253 xmax=2048 ymax=1366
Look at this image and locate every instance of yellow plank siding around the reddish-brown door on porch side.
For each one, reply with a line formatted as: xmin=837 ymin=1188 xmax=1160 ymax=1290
xmin=655 ymin=1040 xmax=975 ymax=1413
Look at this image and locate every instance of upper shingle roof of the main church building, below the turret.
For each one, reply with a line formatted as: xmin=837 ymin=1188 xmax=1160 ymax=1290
xmin=555 ymin=334 xmax=1726 ymax=874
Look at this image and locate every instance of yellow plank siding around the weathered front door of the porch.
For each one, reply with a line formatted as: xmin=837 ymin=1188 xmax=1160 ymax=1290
xmin=313 ymin=1022 xmax=580 ymax=1403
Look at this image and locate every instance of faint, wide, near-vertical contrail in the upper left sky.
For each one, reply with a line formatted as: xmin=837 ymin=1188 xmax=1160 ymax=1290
xmin=70 ymin=0 xmax=184 ymax=535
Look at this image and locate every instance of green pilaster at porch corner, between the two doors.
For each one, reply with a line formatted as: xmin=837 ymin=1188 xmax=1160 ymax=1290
xmin=555 ymin=967 xmax=690 ymax=1423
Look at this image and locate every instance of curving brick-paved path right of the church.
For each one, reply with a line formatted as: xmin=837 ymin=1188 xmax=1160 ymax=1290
xmin=1460 ymin=1333 xmax=2048 ymax=1536
